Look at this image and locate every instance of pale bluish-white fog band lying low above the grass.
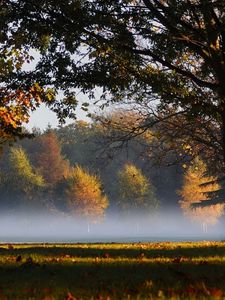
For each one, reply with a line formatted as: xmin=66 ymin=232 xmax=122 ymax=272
xmin=0 ymin=213 xmax=225 ymax=243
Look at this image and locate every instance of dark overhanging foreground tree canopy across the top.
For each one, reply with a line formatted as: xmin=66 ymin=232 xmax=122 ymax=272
xmin=0 ymin=0 xmax=225 ymax=166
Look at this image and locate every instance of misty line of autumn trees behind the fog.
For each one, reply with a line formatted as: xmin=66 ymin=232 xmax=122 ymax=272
xmin=0 ymin=110 xmax=224 ymax=230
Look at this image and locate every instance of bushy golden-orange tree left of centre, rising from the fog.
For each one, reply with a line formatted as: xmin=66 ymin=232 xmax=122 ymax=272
xmin=66 ymin=165 xmax=108 ymax=231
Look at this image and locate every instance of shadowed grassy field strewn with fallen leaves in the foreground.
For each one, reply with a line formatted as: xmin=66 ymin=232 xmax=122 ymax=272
xmin=0 ymin=242 xmax=225 ymax=300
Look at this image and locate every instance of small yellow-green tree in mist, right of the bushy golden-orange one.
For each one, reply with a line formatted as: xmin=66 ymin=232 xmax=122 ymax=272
xmin=118 ymin=163 xmax=159 ymax=220
